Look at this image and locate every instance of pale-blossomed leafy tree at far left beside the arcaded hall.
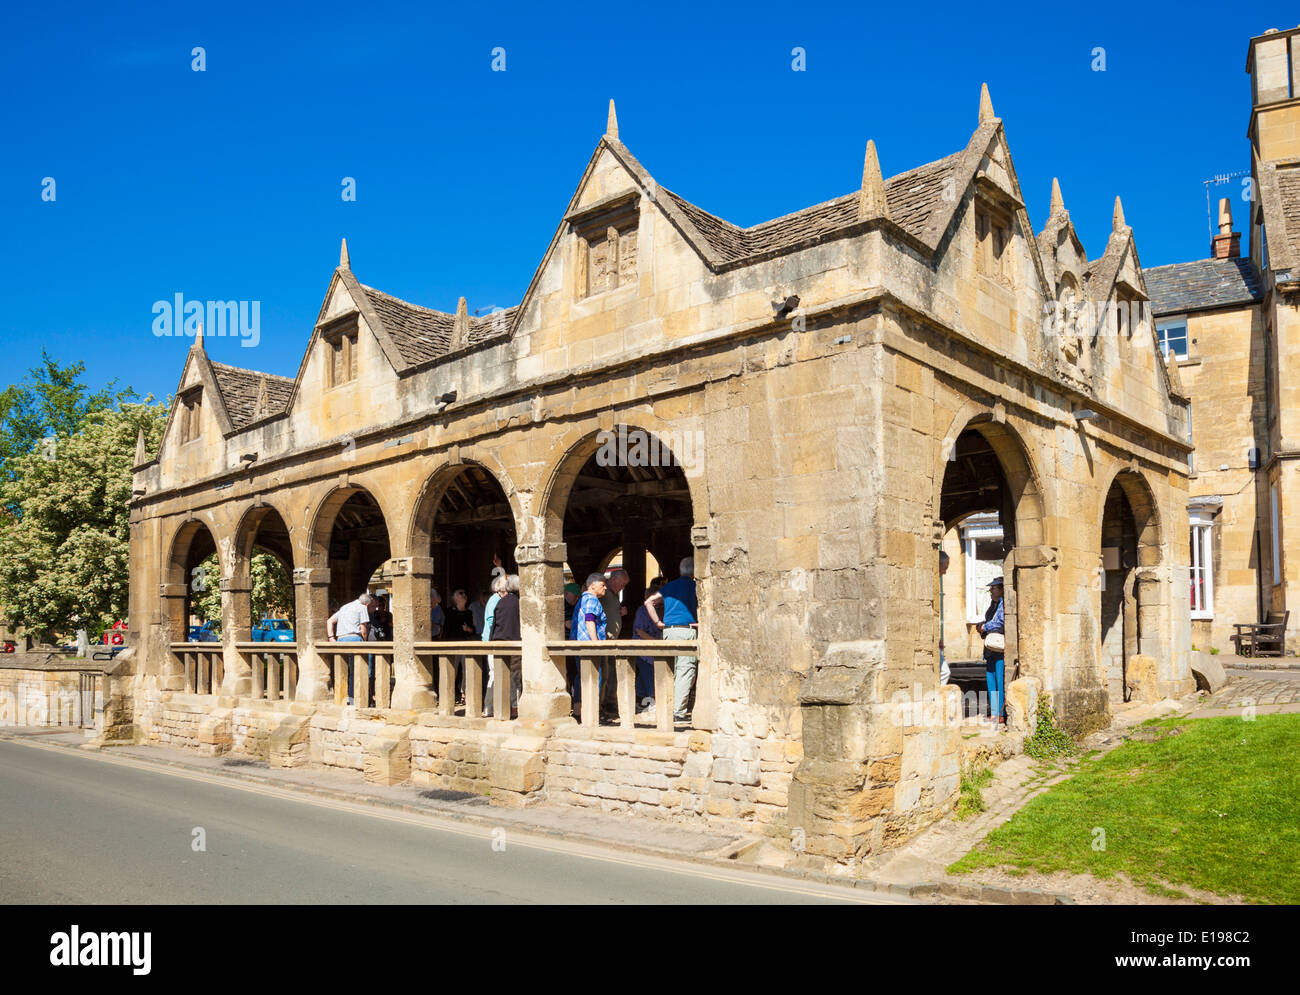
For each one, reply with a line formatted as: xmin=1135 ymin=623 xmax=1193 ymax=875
xmin=0 ymin=400 xmax=168 ymax=640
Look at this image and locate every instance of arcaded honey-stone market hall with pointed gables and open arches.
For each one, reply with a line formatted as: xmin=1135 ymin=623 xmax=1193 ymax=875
xmin=124 ymin=90 xmax=1193 ymax=861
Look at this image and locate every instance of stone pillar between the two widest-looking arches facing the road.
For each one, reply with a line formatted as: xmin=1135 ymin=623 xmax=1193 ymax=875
xmin=515 ymin=538 xmax=573 ymax=719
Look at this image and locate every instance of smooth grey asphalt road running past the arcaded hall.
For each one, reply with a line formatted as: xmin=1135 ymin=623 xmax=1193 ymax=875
xmin=0 ymin=740 xmax=887 ymax=904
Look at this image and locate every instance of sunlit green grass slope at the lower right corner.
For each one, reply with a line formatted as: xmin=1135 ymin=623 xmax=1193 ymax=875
xmin=949 ymin=715 xmax=1300 ymax=904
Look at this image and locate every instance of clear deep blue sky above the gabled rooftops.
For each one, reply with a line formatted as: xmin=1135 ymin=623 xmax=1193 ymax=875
xmin=0 ymin=0 xmax=1297 ymax=397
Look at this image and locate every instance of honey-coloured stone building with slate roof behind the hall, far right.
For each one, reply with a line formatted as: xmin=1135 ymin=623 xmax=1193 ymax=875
xmin=1147 ymin=21 xmax=1300 ymax=653
